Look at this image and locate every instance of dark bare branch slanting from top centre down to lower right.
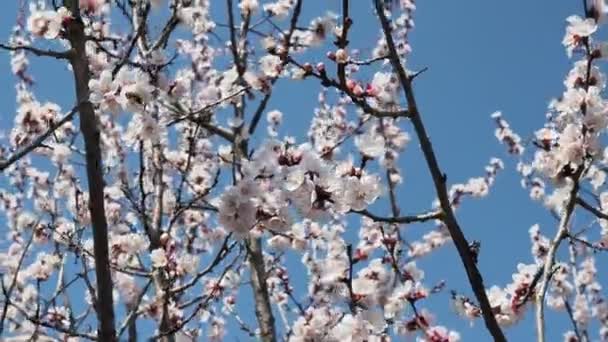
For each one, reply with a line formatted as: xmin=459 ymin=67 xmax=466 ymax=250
xmin=374 ymin=0 xmax=506 ymax=342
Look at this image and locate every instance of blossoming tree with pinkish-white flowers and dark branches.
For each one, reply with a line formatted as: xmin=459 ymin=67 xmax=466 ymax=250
xmin=0 ymin=0 xmax=608 ymax=341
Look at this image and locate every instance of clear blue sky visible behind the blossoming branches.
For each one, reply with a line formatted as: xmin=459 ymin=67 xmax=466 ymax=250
xmin=0 ymin=0 xmax=606 ymax=341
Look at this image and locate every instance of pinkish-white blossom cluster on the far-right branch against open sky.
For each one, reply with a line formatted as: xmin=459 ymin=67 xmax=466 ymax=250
xmin=489 ymin=1 xmax=608 ymax=341
